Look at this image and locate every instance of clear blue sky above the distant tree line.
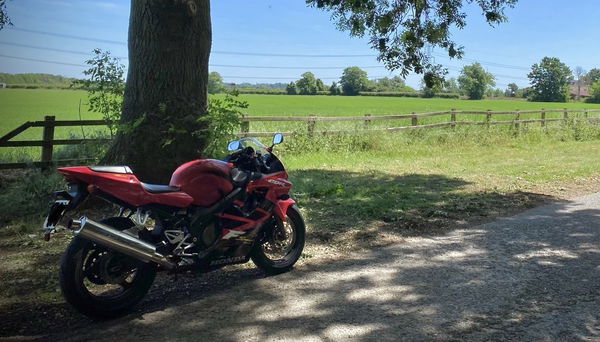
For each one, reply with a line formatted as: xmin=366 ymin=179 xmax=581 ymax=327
xmin=0 ymin=0 xmax=600 ymax=89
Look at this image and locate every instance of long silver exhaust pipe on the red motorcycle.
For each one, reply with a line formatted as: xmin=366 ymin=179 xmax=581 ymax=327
xmin=68 ymin=216 xmax=176 ymax=269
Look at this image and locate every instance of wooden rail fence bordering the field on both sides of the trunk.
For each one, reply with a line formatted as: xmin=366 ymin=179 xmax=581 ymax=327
xmin=0 ymin=109 xmax=600 ymax=169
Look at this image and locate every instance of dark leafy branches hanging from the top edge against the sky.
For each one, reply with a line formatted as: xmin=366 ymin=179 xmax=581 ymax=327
xmin=306 ymin=0 xmax=517 ymax=81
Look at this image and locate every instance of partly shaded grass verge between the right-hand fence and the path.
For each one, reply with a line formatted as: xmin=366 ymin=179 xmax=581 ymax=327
xmin=282 ymin=124 xmax=600 ymax=245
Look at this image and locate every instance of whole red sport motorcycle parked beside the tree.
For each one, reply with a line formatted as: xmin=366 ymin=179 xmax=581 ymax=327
xmin=44 ymin=133 xmax=305 ymax=318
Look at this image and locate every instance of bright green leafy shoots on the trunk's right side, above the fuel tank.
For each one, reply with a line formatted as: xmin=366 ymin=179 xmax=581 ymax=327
xmin=200 ymin=92 xmax=248 ymax=157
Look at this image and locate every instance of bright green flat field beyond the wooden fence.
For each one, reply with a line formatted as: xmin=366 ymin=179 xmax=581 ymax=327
xmin=0 ymin=89 xmax=600 ymax=139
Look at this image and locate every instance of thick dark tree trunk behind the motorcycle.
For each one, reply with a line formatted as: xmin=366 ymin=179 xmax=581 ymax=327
xmin=105 ymin=0 xmax=212 ymax=183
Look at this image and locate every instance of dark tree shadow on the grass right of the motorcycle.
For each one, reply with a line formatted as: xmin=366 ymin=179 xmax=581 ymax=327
xmin=290 ymin=169 xmax=555 ymax=246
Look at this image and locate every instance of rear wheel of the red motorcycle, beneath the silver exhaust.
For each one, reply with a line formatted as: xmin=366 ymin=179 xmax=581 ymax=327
xmin=59 ymin=217 xmax=156 ymax=319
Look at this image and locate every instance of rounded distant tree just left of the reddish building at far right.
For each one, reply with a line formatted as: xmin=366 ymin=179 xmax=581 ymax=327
xmin=527 ymin=57 xmax=571 ymax=102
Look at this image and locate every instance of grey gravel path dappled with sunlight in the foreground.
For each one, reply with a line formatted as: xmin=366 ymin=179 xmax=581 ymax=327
xmin=48 ymin=194 xmax=600 ymax=341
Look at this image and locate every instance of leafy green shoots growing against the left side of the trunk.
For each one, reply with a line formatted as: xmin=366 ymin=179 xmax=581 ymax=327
xmin=74 ymin=49 xmax=125 ymax=135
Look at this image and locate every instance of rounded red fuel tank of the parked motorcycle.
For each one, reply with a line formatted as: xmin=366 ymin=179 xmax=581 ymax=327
xmin=169 ymin=159 xmax=233 ymax=207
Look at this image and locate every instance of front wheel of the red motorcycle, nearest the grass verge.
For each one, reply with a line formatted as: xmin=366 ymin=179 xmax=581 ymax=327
xmin=250 ymin=205 xmax=306 ymax=274
